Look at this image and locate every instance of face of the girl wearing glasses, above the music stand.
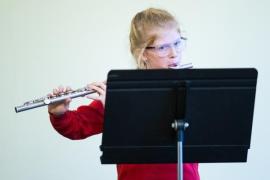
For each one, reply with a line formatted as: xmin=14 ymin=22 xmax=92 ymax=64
xmin=142 ymin=27 xmax=184 ymax=69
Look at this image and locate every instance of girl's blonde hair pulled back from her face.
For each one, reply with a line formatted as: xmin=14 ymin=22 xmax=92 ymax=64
xmin=129 ymin=8 xmax=180 ymax=69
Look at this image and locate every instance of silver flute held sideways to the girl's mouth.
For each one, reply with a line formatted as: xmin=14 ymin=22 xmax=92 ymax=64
xmin=15 ymin=63 xmax=193 ymax=113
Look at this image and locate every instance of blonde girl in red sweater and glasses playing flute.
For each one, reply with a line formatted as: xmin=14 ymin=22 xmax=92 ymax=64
xmin=48 ymin=8 xmax=200 ymax=180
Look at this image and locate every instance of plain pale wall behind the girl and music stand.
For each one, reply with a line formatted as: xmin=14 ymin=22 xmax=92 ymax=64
xmin=0 ymin=0 xmax=270 ymax=180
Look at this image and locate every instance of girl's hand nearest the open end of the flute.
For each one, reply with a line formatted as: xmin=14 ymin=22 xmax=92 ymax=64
xmin=48 ymin=86 xmax=72 ymax=116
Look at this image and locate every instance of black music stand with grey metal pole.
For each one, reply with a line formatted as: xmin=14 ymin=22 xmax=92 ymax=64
xmin=100 ymin=68 xmax=257 ymax=179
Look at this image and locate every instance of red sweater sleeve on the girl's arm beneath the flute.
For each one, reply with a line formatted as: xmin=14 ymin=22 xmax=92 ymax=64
xmin=50 ymin=101 xmax=104 ymax=140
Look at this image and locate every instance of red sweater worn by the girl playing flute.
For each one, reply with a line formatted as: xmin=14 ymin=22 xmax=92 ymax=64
xmin=50 ymin=101 xmax=200 ymax=180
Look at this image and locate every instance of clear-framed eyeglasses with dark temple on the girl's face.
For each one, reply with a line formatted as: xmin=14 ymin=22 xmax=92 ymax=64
xmin=145 ymin=37 xmax=187 ymax=57
